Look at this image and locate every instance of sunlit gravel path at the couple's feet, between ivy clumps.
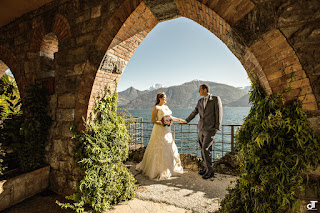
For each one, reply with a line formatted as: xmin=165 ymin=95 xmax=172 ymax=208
xmin=127 ymin=162 xmax=236 ymax=212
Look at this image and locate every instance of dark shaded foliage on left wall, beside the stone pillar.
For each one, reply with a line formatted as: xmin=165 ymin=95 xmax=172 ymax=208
xmin=0 ymin=85 xmax=52 ymax=172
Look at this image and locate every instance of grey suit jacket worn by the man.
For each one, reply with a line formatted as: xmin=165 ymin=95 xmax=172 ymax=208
xmin=186 ymin=94 xmax=223 ymax=132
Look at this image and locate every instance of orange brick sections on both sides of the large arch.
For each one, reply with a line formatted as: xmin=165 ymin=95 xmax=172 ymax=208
xmin=75 ymin=0 xmax=318 ymax=125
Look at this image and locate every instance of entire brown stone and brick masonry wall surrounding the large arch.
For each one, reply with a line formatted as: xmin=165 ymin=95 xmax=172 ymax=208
xmin=0 ymin=0 xmax=320 ymax=206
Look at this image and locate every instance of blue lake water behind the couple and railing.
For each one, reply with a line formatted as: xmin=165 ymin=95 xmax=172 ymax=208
xmin=120 ymin=107 xmax=250 ymax=160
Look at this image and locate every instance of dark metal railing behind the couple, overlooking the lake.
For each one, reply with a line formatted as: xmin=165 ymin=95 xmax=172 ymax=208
xmin=126 ymin=117 xmax=241 ymax=161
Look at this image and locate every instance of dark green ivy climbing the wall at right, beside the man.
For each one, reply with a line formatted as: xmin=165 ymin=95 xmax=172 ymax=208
xmin=220 ymin=79 xmax=320 ymax=213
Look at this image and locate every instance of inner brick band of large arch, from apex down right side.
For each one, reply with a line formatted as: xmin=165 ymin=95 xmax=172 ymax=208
xmin=176 ymin=0 xmax=272 ymax=94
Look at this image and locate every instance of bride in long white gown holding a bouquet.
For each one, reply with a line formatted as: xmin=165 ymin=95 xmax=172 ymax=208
xmin=136 ymin=92 xmax=183 ymax=180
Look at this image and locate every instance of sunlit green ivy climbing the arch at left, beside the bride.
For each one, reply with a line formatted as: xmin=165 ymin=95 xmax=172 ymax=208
xmin=57 ymin=89 xmax=136 ymax=212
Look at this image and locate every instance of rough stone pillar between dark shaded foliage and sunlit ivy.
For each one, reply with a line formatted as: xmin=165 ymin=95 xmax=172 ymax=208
xmin=46 ymin=48 xmax=83 ymax=195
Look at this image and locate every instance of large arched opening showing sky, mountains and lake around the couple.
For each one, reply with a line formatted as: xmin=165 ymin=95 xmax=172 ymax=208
xmin=118 ymin=17 xmax=251 ymax=161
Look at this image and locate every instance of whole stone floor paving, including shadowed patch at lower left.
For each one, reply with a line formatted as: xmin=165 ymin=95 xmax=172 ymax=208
xmin=3 ymin=162 xmax=236 ymax=213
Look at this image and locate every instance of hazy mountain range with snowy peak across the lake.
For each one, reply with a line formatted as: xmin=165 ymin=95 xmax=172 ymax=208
xmin=118 ymin=80 xmax=250 ymax=109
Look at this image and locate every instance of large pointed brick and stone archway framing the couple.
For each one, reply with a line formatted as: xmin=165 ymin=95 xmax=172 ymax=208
xmin=71 ymin=0 xmax=320 ymax=204
